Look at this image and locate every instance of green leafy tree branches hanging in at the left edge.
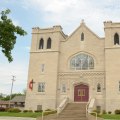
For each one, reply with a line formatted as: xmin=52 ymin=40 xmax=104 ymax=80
xmin=0 ymin=9 xmax=27 ymax=62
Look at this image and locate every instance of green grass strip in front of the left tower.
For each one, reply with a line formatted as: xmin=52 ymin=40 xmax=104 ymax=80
xmin=0 ymin=112 xmax=41 ymax=118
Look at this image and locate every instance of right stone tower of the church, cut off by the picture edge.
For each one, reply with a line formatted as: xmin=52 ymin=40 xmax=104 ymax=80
xmin=104 ymin=21 xmax=120 ymax=111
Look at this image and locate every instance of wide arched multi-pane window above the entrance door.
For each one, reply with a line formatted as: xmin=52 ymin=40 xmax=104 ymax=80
xmin=70 ymin=53 xmax=94 ymax=70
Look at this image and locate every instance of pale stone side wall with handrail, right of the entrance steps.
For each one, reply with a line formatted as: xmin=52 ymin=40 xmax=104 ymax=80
xmin=86 ymin=98 xmax=97 ymax=120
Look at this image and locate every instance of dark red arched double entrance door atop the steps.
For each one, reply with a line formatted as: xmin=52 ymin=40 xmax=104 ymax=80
xmin=74 ymin=84 xmax=89 ymax=102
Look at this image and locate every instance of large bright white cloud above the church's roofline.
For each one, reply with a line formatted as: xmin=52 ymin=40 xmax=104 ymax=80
xmin=22 ymin=0 xmax=120 ymax=36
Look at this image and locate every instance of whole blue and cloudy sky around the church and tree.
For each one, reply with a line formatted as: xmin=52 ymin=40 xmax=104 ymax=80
xmin=0 ymin=0 xmax=120 ymax=94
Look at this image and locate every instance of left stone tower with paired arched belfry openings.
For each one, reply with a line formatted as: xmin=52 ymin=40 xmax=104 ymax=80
xmin=25 ymin=26 xmax=65 ymax=110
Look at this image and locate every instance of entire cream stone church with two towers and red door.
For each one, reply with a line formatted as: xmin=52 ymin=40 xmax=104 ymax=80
xmin=25 ymin=21 xmax=120 ymax=112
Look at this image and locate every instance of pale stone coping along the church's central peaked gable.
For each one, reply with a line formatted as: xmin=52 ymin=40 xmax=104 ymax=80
xmin=66 ymin=21 xmax=101 ymax=40
